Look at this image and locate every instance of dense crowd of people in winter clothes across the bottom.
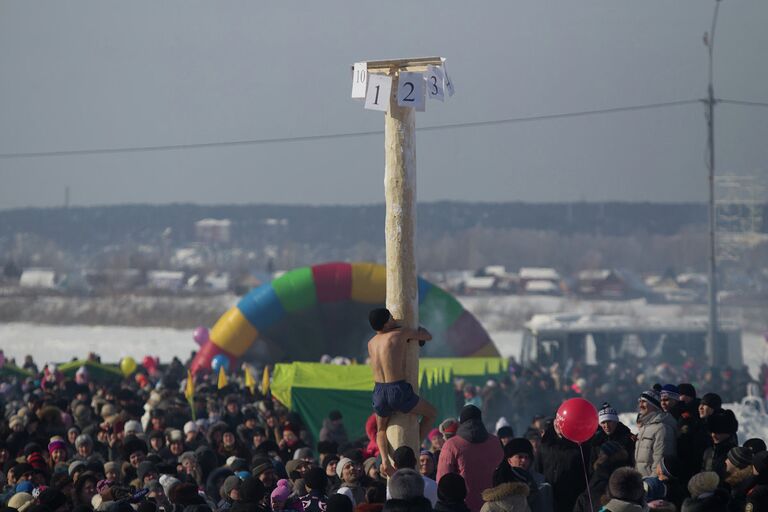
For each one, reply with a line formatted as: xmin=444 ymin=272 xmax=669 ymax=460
xmin=0 ymin=352 xmax=768 ymax=512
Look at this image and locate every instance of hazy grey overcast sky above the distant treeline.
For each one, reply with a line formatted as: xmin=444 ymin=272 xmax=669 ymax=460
xmin=0 ymin=0 xmax=768 ymax=209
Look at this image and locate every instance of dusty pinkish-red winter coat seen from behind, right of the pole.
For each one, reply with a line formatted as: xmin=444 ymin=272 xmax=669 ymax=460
xmin=436 ymin=419 xmax=504 ymax=512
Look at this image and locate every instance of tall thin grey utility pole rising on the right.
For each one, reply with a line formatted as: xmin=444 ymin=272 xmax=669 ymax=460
xmin=704 ymin=0 xmax=720 ymax=366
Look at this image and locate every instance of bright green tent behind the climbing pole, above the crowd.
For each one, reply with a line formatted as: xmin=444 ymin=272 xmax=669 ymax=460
xmin=270 ymin=357 xmax=507 ymax=439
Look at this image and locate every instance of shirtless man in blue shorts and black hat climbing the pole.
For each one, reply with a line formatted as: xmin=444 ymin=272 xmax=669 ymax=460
xmin=368 ymin=308 xmax=437 ymax=476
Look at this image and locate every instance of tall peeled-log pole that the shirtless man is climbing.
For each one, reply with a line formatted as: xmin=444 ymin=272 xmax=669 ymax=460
xmin=384 ymin=68 xmax=421 ymax=453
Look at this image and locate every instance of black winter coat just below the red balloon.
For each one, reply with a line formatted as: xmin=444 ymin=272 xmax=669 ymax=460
xmin=535 ymin=427 xmax=591 ymax=512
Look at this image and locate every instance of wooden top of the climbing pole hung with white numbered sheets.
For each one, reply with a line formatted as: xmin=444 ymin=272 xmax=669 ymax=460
xmin=352 ymin=57 xmax=453 ymax=112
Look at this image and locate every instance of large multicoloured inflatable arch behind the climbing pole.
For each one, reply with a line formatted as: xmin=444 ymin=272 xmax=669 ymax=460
xmin=192 ymin=263 xmax=499 ymax=372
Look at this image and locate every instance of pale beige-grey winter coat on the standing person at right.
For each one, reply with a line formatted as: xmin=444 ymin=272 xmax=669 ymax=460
xmin=635 ymin=411 xmax=677 ymax=478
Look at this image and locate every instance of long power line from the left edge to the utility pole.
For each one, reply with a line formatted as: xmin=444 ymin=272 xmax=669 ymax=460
xmin=0 ymin=100 xmax=701 ymax=159
